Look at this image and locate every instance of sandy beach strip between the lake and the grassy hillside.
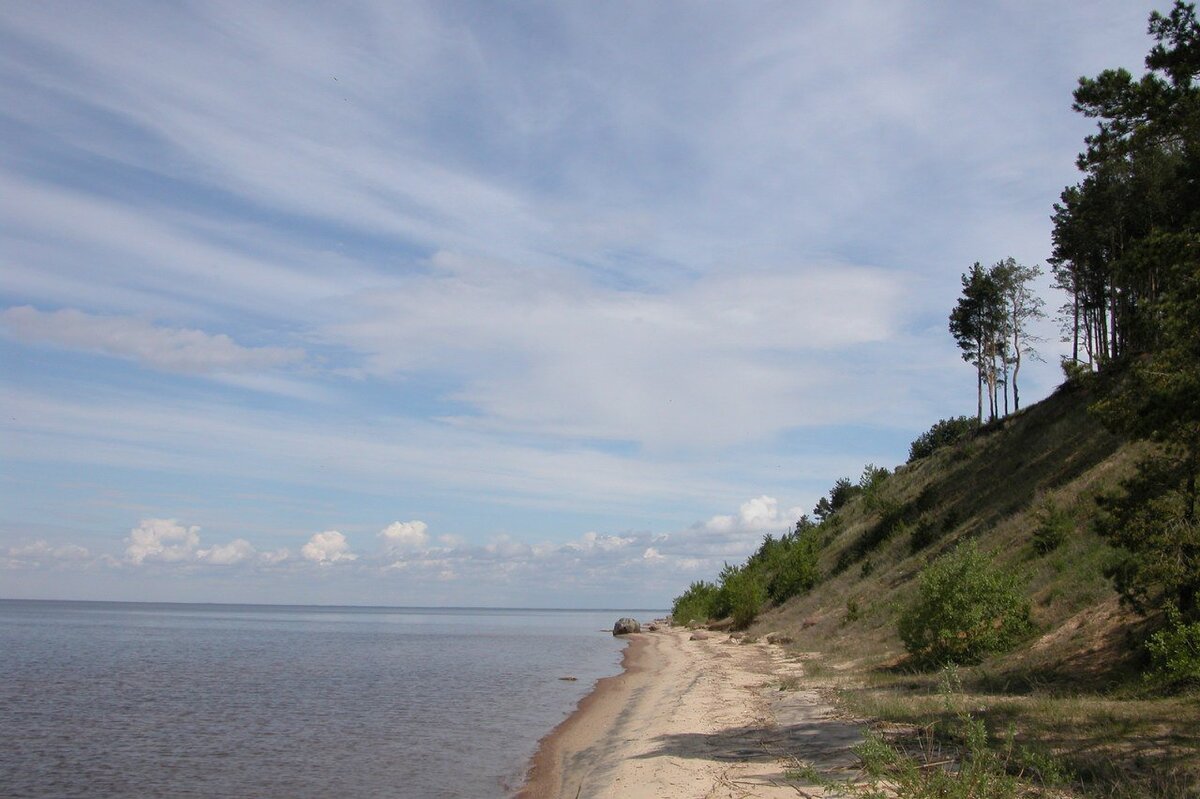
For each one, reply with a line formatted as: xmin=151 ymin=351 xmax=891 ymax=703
xmin=518 ymin=627 xmax=862 ymax=799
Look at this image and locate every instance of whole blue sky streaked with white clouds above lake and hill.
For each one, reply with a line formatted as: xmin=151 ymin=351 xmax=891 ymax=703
xmin=0 ymin=0 xmax=1165 ymax=608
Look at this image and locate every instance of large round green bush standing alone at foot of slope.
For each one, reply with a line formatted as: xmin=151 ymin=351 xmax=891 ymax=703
xmin=899 ymin=542 xmax=1033 ymax=665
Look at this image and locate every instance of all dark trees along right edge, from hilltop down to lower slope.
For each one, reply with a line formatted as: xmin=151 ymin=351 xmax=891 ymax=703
xmin=1051 ymin=1 xmax=1200 ymax=628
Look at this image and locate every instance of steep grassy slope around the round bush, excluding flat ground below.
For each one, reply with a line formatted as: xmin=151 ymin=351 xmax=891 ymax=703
xmin=754 ymin=376 xmax=1141 ymax=684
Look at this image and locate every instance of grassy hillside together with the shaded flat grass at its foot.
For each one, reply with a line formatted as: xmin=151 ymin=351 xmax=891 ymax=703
xmin=696 ymin=382 xmax=1200 ymax=798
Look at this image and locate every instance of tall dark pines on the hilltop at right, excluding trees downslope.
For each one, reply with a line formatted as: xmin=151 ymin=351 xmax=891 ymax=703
xmin=1051 ymin=1 xmax=1200 ymax=370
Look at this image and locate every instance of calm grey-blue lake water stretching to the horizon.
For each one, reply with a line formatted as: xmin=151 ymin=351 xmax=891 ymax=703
xmin=0 ymin=600 xmax=661 ymax=799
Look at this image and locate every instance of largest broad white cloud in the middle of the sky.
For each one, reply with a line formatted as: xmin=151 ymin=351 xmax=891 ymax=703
xmin=323 ymin=252 xmax=910 ymax=447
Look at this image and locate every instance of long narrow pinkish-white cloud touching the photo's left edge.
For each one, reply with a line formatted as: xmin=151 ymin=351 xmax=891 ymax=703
xmin=0 ymin=306 xmax=305 ymax=374
